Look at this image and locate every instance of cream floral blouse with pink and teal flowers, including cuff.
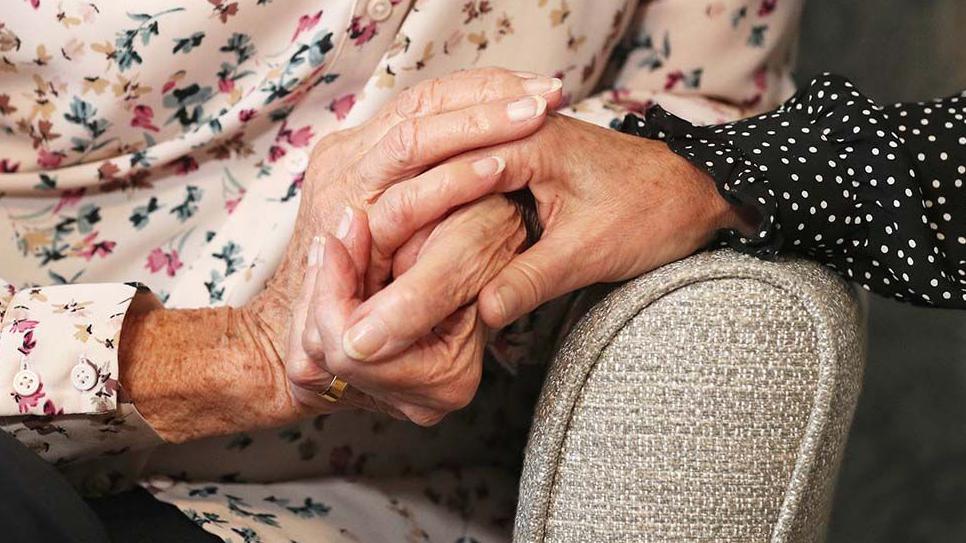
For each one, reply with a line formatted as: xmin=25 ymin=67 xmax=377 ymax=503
xmin=0 ymin=0 xmax=802 ymax=542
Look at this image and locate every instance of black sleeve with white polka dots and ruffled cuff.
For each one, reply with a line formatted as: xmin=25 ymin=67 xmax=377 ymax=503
xmin=621 ymin=74 xmax=966 ymax=308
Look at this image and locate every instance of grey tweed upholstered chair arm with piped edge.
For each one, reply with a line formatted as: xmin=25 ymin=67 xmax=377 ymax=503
xmin=514 ymin=251 xmax=865 ymax=542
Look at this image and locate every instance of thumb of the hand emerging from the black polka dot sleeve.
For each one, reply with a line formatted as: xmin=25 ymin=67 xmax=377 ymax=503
xmin=479 ymin=236 xmax=594 ymax=328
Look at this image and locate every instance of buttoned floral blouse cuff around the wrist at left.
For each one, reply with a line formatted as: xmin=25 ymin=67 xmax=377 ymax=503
xmin=0 ymin=279 xmax=160 ymax=464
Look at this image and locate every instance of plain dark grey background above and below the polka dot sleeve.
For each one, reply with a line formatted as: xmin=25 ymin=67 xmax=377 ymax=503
xmin=798 ymin=0 xmax=966 ymax=543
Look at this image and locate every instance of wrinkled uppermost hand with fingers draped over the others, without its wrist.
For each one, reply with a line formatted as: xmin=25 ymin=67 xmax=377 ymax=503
xmin=249 ymin=68 xmax=561 ymax=416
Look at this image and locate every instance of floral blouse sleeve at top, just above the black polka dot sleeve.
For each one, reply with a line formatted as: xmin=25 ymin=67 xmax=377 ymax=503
xmin=564 ymin=0 xmax=804 ymax=126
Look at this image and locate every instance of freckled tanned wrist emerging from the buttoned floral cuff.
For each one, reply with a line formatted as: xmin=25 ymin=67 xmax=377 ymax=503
xmin=119 ymin=307 xmax=295 ymax=442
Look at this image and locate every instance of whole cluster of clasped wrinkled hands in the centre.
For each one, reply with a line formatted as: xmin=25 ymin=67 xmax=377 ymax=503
xmin=269 ymin=69 xmax=747 ymax=425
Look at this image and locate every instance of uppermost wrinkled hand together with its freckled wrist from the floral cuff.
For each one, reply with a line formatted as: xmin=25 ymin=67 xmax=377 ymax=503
xmin=120 ymin=69 xmax=561 ymax=442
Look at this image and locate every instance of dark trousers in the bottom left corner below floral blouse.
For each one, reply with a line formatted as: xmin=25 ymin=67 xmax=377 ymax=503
xmin=0 ymin=431 xmax=220 ymax=543
